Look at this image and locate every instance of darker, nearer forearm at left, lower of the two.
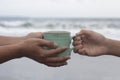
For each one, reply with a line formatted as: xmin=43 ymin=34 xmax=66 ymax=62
xmin=0 ymin=45 xmax=21 ymax=63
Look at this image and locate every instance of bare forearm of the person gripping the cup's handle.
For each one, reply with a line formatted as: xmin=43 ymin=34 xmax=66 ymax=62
xmin=108 ymin=39 xmax=120 ymax=57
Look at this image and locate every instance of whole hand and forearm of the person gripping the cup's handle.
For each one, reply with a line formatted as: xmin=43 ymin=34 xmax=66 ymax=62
xmin=73 ymin=30 xmax=120 ymax=57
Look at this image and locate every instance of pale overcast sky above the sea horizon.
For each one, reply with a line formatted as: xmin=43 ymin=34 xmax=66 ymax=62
xmin=0 ymin=0 xmax=120 ymax=18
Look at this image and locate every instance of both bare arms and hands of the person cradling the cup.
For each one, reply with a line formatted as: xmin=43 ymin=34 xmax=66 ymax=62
xmin=0 ymin=33 xmax=70 ymax=67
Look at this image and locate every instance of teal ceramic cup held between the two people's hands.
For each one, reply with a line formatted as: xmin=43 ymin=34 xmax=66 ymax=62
xmin=44 ymin=31 xmax=72 ymax=56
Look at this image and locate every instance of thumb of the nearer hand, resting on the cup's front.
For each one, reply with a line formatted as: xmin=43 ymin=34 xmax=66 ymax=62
xmin=37 ymin=39 xmax=57 ymax=48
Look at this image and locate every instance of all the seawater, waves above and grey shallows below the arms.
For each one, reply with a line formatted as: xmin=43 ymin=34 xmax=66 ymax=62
xmin=0 ymin=18 xmax=120 ymax=80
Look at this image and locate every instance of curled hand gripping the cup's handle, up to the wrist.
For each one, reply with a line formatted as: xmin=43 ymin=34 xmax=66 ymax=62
xmin=73 ymin=30 xmax=108 ymax=56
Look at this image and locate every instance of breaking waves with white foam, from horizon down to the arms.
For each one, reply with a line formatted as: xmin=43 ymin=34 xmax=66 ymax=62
xmin=0 ymin=19 xmax=120 ymax=36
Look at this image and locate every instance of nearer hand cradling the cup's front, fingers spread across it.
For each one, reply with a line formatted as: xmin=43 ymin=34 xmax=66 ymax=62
xmin=18 ymin=38 xmax=70 ymax=67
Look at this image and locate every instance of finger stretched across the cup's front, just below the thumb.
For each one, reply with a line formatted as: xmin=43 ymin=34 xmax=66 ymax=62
xmin=44 ymin=47 xmax=67 ymax=57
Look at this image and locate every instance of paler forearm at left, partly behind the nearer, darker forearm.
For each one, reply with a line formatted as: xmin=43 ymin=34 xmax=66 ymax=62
xmin=0 ymin=36 xmax=26 ymax=46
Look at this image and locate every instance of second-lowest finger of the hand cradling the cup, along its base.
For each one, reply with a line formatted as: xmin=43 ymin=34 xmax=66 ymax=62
xmin=43 ymin=56 xmax=70 ymax=63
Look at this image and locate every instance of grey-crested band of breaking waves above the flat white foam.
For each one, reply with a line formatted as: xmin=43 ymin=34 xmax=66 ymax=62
xmin=0 ymin=20 xmax=120 ymax=29
